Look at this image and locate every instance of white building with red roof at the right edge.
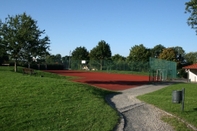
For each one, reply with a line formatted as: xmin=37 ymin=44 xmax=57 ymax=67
xmin=183 ymin=63 xmax=197 ymax=82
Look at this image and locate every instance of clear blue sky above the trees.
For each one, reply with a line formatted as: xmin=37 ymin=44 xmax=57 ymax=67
xmin=0 ymin=0 xmax=197 ymax=56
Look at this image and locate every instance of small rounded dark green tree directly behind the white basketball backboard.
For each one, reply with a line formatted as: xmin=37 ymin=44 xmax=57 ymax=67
xmin=72 ymin=46 xmax=89 ymax=60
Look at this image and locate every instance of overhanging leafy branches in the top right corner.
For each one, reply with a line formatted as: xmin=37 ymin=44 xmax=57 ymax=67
xmin=185 ymin=0 xmax=197 ymax=33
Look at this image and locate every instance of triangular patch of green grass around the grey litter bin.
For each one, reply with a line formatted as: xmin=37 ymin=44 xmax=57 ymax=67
xmin=138 ymin=83 xmax=197 ymax=130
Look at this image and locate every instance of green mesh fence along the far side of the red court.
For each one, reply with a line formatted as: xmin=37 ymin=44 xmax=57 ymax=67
xmin=70 ymin=58 xmax=177 ymax=81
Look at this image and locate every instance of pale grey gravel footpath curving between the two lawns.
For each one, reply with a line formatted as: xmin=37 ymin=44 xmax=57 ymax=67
xmin=106 ymin=83 xmax=173 ymax=131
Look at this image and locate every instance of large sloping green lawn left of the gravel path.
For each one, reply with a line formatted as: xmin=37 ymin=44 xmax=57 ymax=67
xmin=0 ymin=67 xmax=119 ymax=131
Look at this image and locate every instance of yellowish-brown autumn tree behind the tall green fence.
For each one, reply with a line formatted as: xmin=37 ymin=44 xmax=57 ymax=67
xmin=158 ymin=47 xmax=176 ymax=61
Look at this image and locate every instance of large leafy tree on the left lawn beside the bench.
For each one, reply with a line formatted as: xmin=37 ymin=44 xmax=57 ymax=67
xmin=1 ymin=13 xmax=50 ymax=72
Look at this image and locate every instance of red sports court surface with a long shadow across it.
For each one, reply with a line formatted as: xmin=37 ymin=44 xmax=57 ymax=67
xmin=47 ymin=70 xmax=149 ymax=91
